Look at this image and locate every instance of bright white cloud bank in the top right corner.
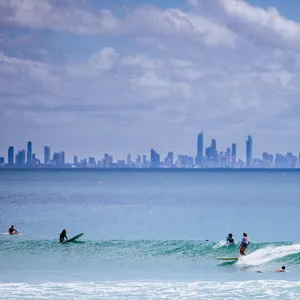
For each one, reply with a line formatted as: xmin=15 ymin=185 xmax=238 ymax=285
xmin=191 ymin=0 xmax=300 ymax=49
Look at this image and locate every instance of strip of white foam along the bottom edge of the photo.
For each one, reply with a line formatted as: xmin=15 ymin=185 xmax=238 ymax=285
xmin=0 ymin=280 xmax=300 ymax=300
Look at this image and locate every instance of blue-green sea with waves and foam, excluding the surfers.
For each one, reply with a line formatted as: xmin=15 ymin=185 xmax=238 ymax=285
xmin=0 ymin=170 xmax=300 ymax=299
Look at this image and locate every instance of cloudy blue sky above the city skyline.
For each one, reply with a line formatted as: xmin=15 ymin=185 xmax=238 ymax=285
xmin=0 ymin=0 xmax=300 ymax=161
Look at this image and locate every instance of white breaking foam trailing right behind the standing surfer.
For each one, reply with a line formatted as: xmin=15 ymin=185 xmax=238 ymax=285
xmin=237 ymin=244 xmax=300 ymax=266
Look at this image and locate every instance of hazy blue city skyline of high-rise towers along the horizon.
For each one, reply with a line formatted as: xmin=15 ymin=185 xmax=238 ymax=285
xmin=0 ymin=132 xmax=300 ymax=169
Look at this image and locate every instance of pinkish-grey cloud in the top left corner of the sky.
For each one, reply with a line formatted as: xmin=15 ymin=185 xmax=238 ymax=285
xmin=0 ymin=0 xmax=118 ymax=34
